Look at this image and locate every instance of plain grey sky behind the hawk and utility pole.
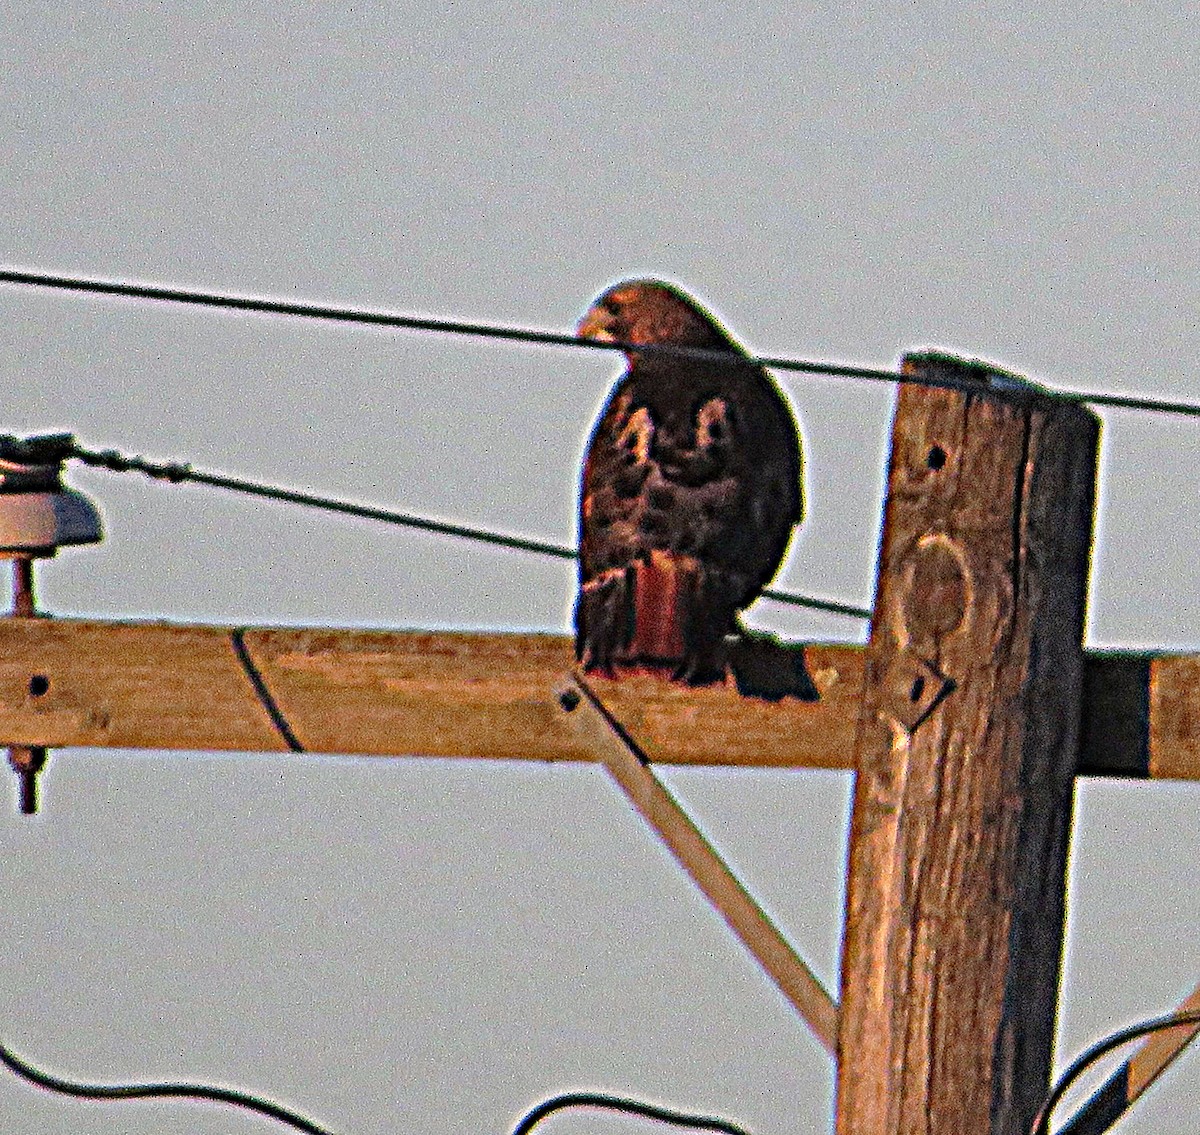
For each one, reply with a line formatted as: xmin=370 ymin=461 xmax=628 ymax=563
xmin=0 ymin=2 xmax=1200 ymax=1135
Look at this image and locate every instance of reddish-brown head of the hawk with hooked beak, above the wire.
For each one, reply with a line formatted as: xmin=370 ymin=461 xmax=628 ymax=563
xmin=575 ymin=280 xmax=738 ymax=350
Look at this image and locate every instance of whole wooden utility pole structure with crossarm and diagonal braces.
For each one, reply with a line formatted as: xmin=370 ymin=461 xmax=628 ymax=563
xmin=0 ymin=364 xmax=1200 ymax=1135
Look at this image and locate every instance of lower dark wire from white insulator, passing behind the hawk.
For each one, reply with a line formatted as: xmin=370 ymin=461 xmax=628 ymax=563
xmin=66 ymin=443 xmax=871 ymax=619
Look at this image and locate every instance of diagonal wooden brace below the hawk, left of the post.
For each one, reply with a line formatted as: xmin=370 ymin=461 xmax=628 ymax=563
xmin=556 ymin=674 xmax=838 ymax=1052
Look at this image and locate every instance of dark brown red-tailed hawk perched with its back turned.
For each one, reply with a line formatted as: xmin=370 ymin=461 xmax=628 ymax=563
xmin=575 ymin=280 xmax=804 ymax=685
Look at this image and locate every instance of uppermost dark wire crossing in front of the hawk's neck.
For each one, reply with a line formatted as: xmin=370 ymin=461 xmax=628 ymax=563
xmin=7 ymin=269 xmax=1200 ymax=418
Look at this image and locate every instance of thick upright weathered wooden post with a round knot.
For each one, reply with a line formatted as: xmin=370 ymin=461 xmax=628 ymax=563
xmin=836 ymin=355 xmax=1098 ymax=1135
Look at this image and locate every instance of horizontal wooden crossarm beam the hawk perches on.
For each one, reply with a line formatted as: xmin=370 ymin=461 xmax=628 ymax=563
xmin=0 ymin=618 xmax=1200 ymax=780
